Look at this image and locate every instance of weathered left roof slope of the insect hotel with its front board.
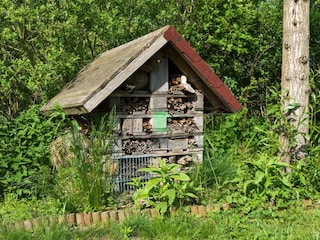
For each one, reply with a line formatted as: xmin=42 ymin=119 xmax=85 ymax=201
xmin=43 ymin=27 xmax=168 ymax=112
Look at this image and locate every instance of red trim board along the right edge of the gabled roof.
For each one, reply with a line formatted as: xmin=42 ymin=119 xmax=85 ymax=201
xmin=164 ymin=26 xmax=241 ymax=112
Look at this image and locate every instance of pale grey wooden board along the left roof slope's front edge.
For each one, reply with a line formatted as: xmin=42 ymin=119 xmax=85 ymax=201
xmin=84 ymin=36 xmax=167 ymax=112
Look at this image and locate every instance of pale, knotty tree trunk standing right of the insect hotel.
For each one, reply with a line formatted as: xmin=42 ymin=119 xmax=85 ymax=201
xmin=280 ymin=0 xmax=310 ymax=163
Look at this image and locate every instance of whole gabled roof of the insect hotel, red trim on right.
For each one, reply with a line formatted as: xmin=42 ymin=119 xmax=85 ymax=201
xmin=41 ymin=26 xmax=241 ymax=114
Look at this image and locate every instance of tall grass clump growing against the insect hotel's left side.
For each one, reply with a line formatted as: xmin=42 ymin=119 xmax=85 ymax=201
xmin=55 ymin=111 xmax=115 ymax=212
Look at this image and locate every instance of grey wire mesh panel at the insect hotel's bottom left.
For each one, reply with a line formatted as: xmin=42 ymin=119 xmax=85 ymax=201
xmin=113 ymin=155 xmax=151 ymax=192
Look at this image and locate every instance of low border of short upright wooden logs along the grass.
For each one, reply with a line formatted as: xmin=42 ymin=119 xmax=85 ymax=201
xmin=7 ymin=204 xmax=223 ymax=230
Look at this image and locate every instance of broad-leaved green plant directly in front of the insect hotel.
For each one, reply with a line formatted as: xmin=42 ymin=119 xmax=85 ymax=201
xmin=132 ymin=160 xmax=202 ymax=216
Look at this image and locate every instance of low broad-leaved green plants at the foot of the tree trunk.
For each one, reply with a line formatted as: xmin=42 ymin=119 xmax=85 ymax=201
xmin=223 ymin=153 xmax=316 ymax=213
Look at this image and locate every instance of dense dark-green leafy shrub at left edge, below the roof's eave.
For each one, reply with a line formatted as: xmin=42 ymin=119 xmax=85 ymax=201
xmin=0 ymin=105 xmax=65 ymax=196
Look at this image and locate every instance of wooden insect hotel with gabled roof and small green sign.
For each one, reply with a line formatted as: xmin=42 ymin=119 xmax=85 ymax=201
xmin=41 ymin=26 xmax=241 ymax=190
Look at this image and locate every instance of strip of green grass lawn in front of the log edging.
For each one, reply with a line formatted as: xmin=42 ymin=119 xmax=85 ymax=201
xmin=0 ymin=208 xmax=320 ymax=240
